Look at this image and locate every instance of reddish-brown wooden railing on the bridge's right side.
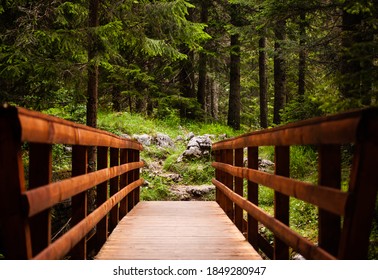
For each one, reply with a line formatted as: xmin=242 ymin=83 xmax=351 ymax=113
xmin=213 ymin=109 xmax=378 ymax=259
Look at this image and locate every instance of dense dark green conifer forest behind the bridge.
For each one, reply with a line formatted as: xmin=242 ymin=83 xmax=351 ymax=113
xmin=0 ymin=0 xmax=378 ymax=129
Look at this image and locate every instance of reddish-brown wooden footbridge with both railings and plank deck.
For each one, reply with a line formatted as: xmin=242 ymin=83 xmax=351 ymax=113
xmin=0 ymin=106 xmax=378 ymax=259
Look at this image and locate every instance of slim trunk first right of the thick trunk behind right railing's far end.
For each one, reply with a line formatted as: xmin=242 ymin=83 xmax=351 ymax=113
xmin=259 ymin=34 xmax=268 ymax=128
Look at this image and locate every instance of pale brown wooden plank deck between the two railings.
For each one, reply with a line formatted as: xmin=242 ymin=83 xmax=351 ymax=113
xmin=96 ymin=201 xmax=261 ymax=260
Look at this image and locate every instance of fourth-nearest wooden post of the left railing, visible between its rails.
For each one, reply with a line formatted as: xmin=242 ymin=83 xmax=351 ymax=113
xmin=96 ymin=147 xmax=109 ymax=251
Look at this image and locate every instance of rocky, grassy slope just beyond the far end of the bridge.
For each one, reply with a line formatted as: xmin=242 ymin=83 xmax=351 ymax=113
xmin=131 ymin=133 xmax=274 ymax=200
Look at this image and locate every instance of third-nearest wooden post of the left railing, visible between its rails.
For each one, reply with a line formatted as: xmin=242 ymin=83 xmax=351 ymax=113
xmin=71 ymin=146 xmax=88 ymax=260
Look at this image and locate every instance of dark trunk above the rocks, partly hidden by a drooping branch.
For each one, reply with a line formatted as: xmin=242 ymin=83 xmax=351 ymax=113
xmin=197 ymin=1 xmax=209 ymax=110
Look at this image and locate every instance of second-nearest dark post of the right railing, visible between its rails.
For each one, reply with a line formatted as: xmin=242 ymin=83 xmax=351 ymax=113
xmin=318 ymin=145 xmax=341 ymax=256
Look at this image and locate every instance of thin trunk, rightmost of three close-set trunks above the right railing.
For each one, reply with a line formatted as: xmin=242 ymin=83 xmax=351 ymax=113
xmin=298 ymin=12 xmax=307 ymax=97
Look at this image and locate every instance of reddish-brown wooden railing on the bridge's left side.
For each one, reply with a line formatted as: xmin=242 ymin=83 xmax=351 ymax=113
xmin=0 ymin=106 xmax=143 ymax=259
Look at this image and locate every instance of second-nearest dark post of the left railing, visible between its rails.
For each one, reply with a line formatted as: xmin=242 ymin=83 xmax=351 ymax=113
xmin=29 ymin=143 xmax=52 ymax=256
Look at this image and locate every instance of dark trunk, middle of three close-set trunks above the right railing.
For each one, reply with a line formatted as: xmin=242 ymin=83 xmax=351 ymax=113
xmin=273 ymin=20 xmax=286 ymax=124
